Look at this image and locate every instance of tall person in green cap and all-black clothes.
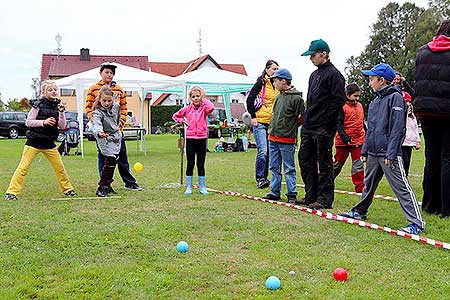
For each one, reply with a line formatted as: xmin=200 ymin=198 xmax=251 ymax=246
xmin=298 ymin=40 xmax=346 ymax=209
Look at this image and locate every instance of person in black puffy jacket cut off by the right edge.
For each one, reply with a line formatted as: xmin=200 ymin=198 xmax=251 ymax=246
xmin=414 ymin=20 xmax=450 ymax=217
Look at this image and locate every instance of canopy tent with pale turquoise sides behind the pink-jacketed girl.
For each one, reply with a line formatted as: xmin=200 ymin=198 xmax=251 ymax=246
xmin=152 ymin=67 xmax=256 ymax=123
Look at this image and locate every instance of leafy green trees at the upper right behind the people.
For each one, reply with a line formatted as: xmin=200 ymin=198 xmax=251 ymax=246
xmin=345 ymin=0 xmax=450 ymax=104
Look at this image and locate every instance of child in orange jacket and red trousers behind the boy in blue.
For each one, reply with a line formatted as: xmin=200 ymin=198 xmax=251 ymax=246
xmin=334 ymin=83 xmax=366 ymax=193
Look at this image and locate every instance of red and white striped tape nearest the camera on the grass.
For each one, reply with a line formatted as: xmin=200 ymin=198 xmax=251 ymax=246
xmin=203 ymin=188 xmax=450 ymax=250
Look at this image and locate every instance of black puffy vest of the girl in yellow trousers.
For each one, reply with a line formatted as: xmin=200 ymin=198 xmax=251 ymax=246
xmin=26 ymin=98 xmax=60 ymax=149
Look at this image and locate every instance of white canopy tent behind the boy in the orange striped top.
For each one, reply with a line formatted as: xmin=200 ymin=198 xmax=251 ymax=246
xmin=56 ymin=63 xmax=185 ymax=157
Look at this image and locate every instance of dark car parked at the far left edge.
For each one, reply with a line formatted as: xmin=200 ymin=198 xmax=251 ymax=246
xmin=0 ymin=111 xmax=28 ymax=139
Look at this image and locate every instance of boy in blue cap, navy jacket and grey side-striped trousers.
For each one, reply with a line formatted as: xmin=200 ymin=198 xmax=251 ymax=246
xmin=341 ymin=64 xmax=425 ymax=234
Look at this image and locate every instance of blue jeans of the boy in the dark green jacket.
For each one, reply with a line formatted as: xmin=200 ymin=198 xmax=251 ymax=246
xmin=269 ymin=141 xmax=297 ymax=197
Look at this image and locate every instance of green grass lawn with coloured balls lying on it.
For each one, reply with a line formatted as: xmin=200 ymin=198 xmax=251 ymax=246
xmin=0 ymin=135 xmax=450 ymax=299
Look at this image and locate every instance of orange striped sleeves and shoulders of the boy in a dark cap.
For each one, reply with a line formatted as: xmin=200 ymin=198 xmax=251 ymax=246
xmin=84 ymin=80 xmax=128 ymax=131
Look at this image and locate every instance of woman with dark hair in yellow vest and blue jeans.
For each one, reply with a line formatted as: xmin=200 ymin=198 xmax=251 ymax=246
xmin=247 ymin=59 xmax=279 ymax=189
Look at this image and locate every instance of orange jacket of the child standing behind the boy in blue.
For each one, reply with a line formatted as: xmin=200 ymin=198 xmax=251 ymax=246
xmin=335 ymin=101 xmax=366 ymax=147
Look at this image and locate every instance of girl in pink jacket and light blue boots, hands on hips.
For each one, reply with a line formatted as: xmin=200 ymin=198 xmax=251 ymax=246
xmin=172 ymin=86 xmax=214 ymax=195
